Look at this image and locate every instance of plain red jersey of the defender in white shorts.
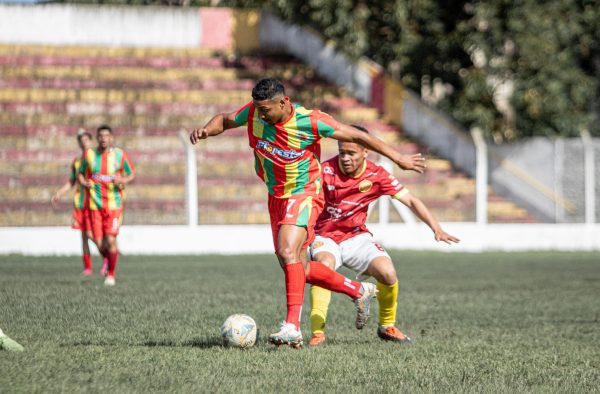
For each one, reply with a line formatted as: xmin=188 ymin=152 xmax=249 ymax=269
xmin=315 ymin=156 xmax=408 ymax=243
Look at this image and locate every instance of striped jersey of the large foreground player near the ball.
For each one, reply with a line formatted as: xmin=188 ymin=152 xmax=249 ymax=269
xmin=235 ymin=102 xmax=338 ymax=198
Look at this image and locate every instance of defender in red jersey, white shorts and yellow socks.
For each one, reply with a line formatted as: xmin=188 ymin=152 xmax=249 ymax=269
xmin=309 ymin=126 xmax=459 ymax=346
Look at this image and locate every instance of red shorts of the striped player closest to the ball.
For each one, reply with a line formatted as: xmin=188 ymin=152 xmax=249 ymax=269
xmin=269 ymin=193 xmax=325 ymax=250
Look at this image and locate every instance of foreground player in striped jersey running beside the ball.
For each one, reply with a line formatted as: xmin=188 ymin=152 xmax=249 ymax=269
xmin=190 ymin=78 xmax=424 ymax=347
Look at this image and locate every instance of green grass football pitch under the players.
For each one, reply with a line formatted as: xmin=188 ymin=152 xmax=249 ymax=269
xmin=0 ymin=252 xmax=600 ymax=393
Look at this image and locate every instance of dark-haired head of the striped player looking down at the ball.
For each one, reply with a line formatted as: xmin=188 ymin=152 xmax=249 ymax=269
xmin=252 ymin=78 xmax=290 ymax=124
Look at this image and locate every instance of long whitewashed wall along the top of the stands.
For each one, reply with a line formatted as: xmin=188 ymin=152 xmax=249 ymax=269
xmin=0 ymin=4 xmax=202 ymax=48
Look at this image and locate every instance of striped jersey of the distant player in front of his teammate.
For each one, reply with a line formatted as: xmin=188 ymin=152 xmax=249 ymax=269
xmin=79 ymin=148 xmax=135 ymax=210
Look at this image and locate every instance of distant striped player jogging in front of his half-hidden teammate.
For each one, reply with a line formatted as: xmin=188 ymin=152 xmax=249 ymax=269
xmin=79 ymin=125 xmax=135 ymax=286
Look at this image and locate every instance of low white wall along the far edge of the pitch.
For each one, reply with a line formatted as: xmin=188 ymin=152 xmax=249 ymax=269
xmin=0 ymin=223 xmax=600 ymax=255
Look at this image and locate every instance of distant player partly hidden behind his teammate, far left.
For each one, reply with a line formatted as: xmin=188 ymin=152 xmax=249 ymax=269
xmin=50 ymin=129 xmax=108 ymax=276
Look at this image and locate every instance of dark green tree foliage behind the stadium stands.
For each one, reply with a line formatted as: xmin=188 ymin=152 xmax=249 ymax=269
xmin=52 ymin=0 xmax=600 ymax=142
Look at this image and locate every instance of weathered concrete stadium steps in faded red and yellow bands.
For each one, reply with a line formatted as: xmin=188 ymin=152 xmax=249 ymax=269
xmin=0 ymin=45 xmax=531 ymax=225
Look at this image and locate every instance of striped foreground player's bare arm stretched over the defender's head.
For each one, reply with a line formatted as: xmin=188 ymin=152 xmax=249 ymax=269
xmin=331 ymin=123 xmax=425 ymax=174
